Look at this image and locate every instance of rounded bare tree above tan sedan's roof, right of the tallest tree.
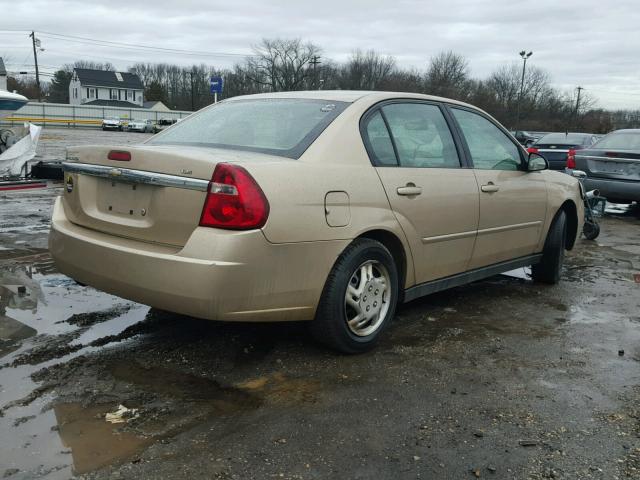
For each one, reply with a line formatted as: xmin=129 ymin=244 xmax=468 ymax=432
xmin=338 ymin=50 xmax=396 ymax=90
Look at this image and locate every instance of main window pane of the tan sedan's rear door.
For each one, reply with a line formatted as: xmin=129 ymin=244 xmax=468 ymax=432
xmin=382 ymin=103 xmax=460 ymax=168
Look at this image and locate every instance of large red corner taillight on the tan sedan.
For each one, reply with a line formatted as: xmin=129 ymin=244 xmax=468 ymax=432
xmin=200 ymin=163 xmax=269 ymax=230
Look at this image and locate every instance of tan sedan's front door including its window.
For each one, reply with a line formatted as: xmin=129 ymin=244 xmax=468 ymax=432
xmin=451 ymin=107 xmax=547 ymax=268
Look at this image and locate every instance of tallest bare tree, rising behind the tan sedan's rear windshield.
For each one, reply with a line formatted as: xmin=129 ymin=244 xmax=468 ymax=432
xmin=245 ymin=38 xmax=321 ymax=92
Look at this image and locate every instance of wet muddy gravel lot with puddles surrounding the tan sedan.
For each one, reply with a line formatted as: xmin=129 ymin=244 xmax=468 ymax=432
xmin=0 ymin=129 xmax=640 ymax=479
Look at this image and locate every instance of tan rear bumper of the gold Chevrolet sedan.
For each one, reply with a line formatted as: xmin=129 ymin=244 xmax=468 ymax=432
xmin=49 ymin=198 xmax=349 ymax=321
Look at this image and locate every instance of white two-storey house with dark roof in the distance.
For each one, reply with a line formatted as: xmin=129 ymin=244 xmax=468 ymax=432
xmin=69 ymin=68 xmax=144 ymax=108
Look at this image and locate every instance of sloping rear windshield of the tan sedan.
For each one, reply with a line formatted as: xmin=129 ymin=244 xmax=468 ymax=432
xmin=147 ymin=98 xmax=349 ymax=158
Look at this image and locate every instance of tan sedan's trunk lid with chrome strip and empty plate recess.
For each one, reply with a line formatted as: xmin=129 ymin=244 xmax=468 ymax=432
xmin=63 ymin=145 xmax=277 ymax=246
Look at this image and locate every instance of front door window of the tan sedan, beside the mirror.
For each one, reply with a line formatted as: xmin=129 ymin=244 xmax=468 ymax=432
xmin=451 ymin=108 xmax=522 ymax=170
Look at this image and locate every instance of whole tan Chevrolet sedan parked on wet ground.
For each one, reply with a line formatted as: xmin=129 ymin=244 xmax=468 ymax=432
xmin=49 ymin=91 xmax=583 ymax=353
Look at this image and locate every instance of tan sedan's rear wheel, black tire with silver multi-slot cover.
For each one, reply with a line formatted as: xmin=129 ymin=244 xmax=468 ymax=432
xmin=310 ymin=238 xmax=398 ymax=354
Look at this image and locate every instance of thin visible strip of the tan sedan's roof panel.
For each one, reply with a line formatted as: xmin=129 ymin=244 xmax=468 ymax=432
xmin=225 ymin=90 xmax=478 ymax=110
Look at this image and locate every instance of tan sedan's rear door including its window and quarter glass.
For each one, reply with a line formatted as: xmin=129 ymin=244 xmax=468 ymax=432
xmin=363 ymin=101 xmax=478 ymax=283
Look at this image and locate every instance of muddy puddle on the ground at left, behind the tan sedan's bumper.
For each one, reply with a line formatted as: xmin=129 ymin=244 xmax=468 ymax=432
xmin=0 ymin=252 xmax=149 ymax=478
